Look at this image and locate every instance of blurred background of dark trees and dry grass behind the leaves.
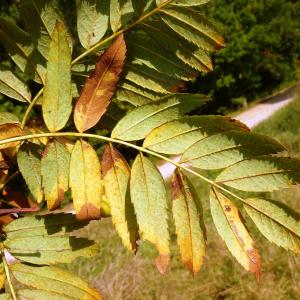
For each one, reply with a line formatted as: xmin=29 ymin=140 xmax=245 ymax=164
xmin=0 ymin=0 xmax=300 ymax=300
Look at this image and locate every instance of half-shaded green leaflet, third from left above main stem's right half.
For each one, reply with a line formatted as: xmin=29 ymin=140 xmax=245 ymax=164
xmin=181 ymin=131 xmax=285 ymax=170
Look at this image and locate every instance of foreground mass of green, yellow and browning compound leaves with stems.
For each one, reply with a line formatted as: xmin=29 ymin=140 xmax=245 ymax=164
xmin=0 ymin=0 xmax=300 ymax=299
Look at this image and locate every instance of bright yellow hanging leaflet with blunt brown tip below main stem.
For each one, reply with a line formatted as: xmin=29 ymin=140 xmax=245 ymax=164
xmin=70 ymin=140 xmax=103 ymax=220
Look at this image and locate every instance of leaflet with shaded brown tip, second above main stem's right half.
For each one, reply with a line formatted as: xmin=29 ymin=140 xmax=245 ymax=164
xmin=143 ymin=116 xmax=249 ymax=154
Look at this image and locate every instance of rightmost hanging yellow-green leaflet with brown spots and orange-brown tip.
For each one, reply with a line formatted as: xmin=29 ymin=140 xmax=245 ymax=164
xmin=210 ymin=189 xmax=260 ymax=278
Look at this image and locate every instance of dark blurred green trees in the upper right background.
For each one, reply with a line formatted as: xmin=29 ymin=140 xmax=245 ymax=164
xmin=193 ymin=0 xmax=300 ymax=113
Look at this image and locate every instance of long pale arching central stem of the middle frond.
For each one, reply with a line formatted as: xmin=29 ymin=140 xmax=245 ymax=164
xmin=0 ymin=132 xmax=244 ymax=202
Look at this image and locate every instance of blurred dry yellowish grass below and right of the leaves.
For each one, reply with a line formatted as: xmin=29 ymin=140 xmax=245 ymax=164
xmin=70 ymin=99 xmax=300 ymax=300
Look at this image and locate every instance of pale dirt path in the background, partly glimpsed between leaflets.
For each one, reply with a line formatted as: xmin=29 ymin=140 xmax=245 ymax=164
xmin=158 ymin=83 xmax=300 ymax=179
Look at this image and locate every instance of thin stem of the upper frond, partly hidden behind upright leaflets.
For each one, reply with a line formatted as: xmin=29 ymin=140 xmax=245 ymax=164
xmin=22 ymin=0 xmax=173 ymax=128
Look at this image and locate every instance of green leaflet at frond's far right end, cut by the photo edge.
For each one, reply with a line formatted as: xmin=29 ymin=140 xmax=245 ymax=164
xmin=244 ymin=198 xmax=300 ymax=253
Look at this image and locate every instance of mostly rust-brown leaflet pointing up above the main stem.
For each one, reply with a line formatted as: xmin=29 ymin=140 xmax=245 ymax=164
xmin=74 ymin=35 xmax=126 ymax=132
